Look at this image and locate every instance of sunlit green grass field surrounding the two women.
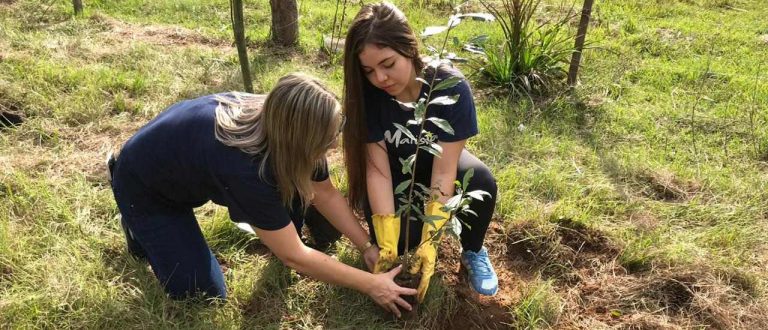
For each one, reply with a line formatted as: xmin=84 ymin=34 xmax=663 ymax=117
xmin=0 ymin=0 xmax=768 ymax=329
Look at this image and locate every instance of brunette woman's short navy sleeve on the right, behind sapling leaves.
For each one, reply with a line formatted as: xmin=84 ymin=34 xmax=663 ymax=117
xmin=437 ymin=78 xmax=478 ymax=142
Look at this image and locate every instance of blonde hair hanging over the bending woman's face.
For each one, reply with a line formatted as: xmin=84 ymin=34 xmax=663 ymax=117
xmin=216 ymin=73 xmax=341 ymax=209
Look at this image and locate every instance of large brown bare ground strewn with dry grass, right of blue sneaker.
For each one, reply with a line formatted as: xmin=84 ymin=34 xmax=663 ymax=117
xmin=500 ymin=218 xmax=768 ymax=329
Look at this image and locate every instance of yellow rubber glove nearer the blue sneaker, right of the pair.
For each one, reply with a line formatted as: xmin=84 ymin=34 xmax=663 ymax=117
xmin=410 ymin=201 xmax=451 ymax=302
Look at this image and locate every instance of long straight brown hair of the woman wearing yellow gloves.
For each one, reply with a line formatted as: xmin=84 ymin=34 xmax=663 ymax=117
xmin=343 ymin=2 xmax=424 ymax=210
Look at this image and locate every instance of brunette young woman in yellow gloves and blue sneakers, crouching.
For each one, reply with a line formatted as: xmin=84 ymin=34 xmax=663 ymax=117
xmin=343 ymin=2 xmax=498 ymax=301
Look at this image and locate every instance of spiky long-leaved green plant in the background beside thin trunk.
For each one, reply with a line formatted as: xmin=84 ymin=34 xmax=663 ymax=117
xmin=475 ymin=0 xmax=576 ymax=97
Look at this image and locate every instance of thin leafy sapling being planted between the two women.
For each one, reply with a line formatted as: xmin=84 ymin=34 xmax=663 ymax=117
xmin=394 ymin=16 xmax=490 ymax=269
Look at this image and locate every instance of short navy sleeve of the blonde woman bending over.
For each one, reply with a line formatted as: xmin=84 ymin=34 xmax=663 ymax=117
xmin=220 ymin=173 xmax=291 ymax=230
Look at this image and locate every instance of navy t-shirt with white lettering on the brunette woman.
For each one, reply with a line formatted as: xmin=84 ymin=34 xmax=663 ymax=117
xmin=365 ymin=67 xmax=478 ymax=185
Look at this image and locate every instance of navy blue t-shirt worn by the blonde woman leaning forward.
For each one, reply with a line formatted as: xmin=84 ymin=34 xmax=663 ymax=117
xmin=113 ymin=94 xmax=328 ymax=230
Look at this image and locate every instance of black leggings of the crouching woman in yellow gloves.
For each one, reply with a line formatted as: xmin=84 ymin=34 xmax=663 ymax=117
xmin=364 ymin=149 xmax=497 ymax=254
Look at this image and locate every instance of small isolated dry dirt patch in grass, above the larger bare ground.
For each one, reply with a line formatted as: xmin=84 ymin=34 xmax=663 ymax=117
xmin=635 ymin=170 xmax=701 ymax=202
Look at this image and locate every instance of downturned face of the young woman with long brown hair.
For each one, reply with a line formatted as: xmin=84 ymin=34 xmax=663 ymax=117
xmin=358 ymin=44 xmax=421 ymax=101
